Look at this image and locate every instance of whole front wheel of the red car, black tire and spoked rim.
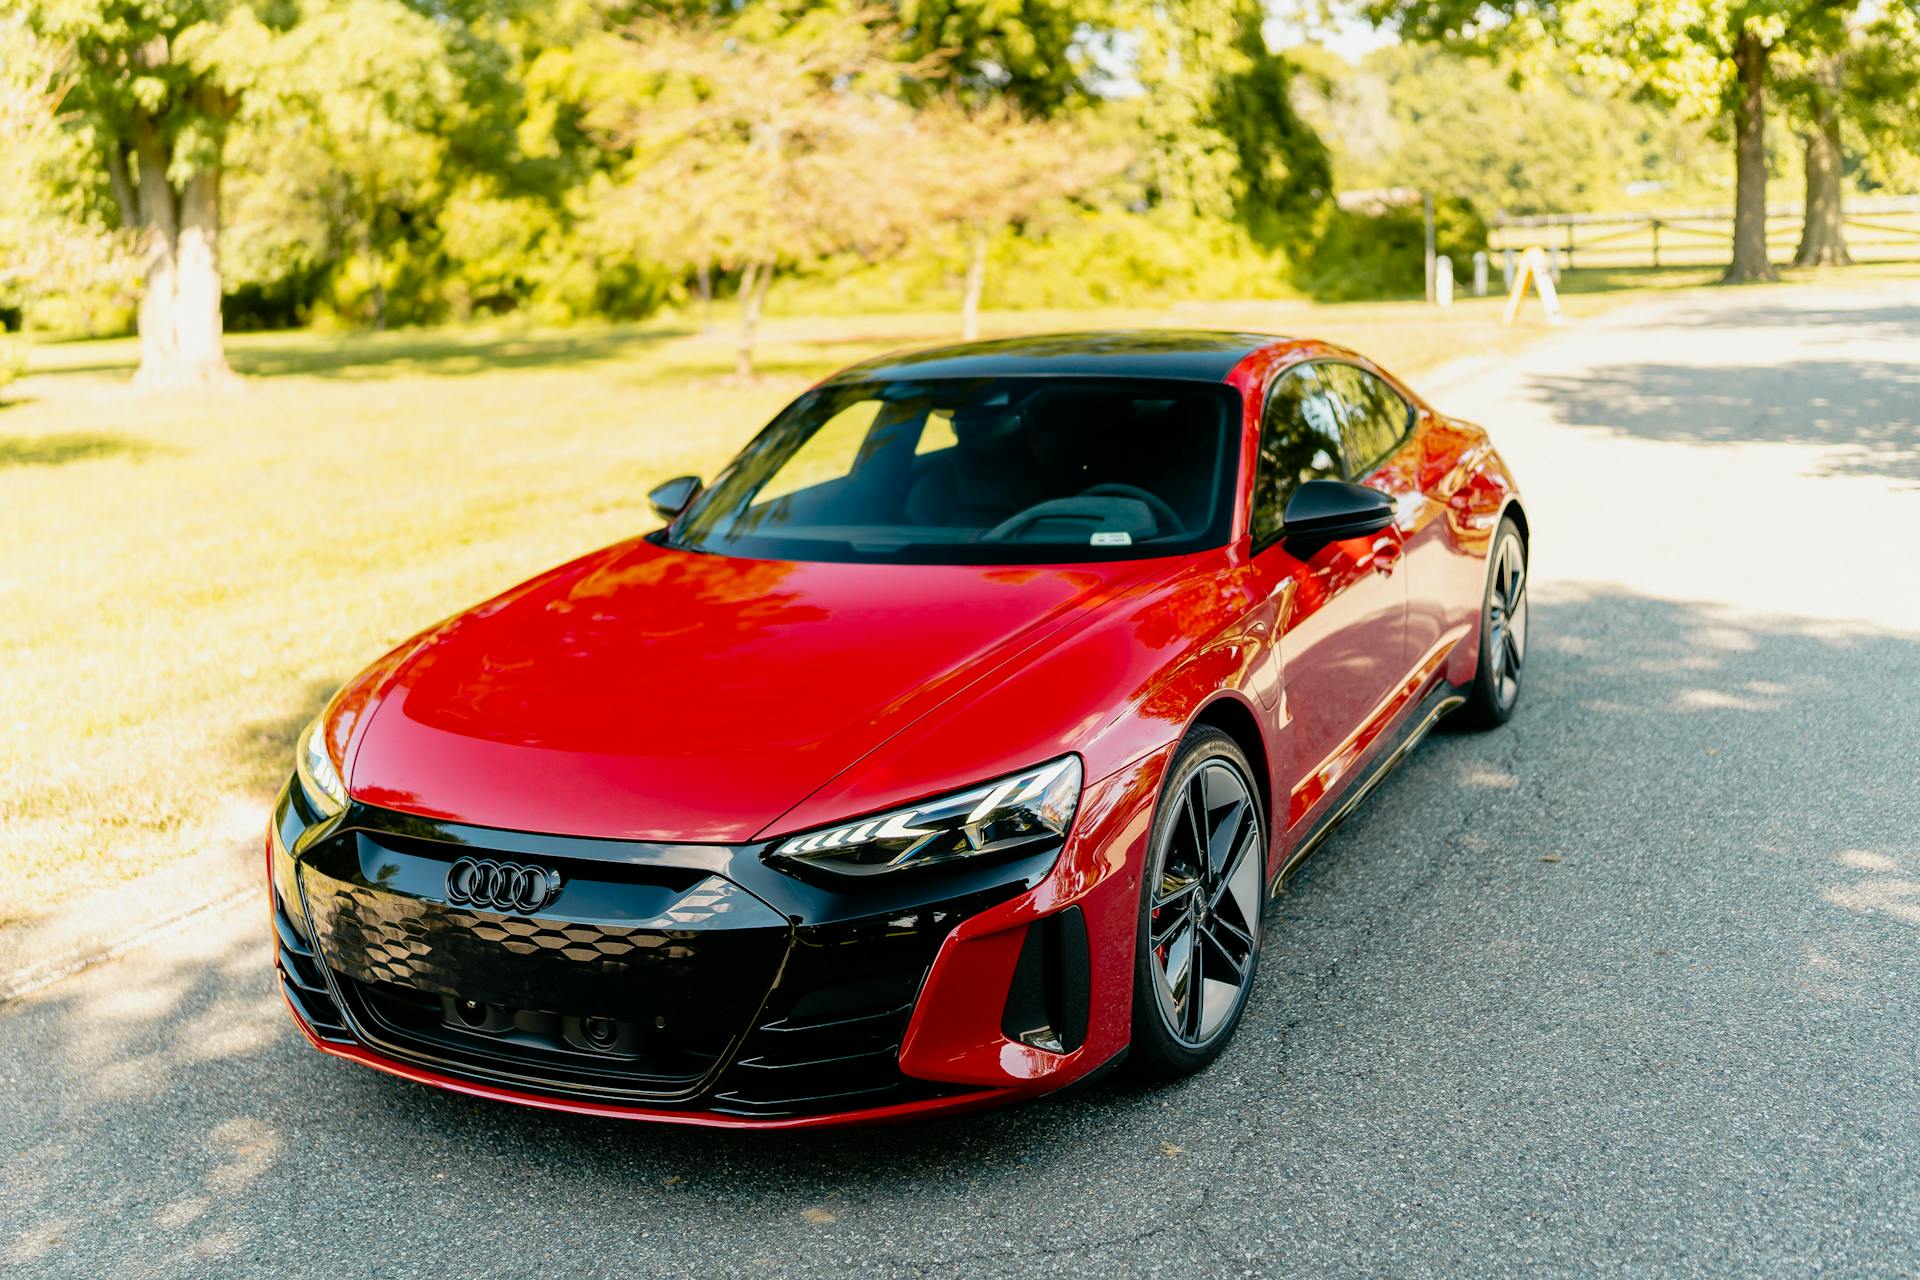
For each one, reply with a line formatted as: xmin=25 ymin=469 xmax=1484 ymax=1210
xmin=1127 ymin=727 xmax=1267 ymax=1080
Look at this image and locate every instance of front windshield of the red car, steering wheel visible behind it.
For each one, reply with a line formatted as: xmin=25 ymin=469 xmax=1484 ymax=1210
xmin=666 ymin=378 xmax=1238 ymax=564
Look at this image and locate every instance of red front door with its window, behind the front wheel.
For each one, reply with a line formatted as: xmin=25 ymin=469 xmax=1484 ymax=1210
xmin=1252 ymin=363 xmax=1407 ymax=841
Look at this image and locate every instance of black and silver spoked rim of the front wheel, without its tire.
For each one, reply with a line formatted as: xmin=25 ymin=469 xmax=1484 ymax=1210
xmin=1146 ymin=758 xmax=1265 ymax=1048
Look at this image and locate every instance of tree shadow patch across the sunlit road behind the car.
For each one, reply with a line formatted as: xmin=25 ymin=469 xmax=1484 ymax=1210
xmin=1530 ymin=355 xmax=1920 ymax=486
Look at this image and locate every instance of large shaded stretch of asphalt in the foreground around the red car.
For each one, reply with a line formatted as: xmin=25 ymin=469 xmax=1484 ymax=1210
xmin=0 ymin=589 xmax=1920 ymax=1274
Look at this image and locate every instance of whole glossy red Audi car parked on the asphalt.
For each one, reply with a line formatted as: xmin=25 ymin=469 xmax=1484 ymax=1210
xmin=267 ymin=332 xmax=1528 ymax=1126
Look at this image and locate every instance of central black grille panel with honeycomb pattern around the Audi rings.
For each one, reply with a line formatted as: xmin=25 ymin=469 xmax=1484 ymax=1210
xmin=300 ymin=831 xmax=791 ymax=1102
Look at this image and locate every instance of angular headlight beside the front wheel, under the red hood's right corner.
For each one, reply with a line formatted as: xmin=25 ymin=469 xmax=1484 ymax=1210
xmin=774 ymin=756 xmax=1081 ymax=875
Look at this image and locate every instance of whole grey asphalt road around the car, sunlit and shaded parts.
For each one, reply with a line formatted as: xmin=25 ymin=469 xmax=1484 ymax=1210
xmin=11 ymin=290 xmax=1920 ymax=1276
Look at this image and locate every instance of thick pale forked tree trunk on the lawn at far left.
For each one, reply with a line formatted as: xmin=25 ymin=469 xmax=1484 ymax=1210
xmin=132 ymin=121 xmax=234 ymax=388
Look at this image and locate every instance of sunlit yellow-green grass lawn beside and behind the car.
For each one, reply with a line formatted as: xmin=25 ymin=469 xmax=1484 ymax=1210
xmin=0 ymin=285 xmax=1651 ymax=923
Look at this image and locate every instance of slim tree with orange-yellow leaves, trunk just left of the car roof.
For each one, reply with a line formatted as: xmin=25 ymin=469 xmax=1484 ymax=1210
xmin=582 ymin=10 xmax=924 ymax=378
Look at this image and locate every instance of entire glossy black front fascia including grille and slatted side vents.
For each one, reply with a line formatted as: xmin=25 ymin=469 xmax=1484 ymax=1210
xmin=275 ymin=802 xmax=1048 ymax=1119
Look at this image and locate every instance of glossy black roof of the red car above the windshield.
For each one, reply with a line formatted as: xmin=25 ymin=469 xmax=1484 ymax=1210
xmin=831 ymin=328 xmax=1286 ymax=382
